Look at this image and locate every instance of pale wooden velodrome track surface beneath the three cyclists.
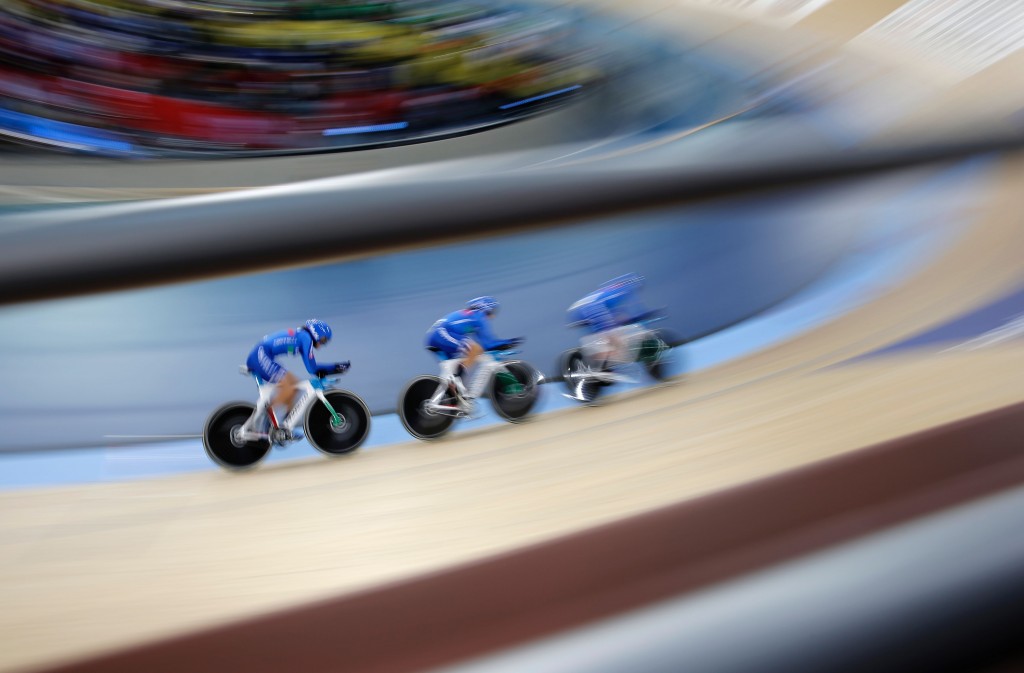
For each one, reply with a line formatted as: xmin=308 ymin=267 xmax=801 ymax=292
xmin=0 ymin=0 xmax=1024 ymax=671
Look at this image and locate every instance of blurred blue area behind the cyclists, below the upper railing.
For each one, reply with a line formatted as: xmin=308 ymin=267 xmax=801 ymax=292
xmin=0 ymin=164 xmax=988 ymax=450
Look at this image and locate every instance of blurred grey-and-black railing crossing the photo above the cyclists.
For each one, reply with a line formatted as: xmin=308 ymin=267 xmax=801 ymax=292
xmin=0 ymin=125 xmax=1024 ymax=304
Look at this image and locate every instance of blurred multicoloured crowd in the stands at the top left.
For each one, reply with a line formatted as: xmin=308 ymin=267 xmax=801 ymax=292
xmin=0 ymin=0 xmax=600 ymax=155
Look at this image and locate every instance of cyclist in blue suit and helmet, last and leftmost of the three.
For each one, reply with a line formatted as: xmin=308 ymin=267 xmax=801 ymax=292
xmin=246 ymin=318 xmax=351 ymax=417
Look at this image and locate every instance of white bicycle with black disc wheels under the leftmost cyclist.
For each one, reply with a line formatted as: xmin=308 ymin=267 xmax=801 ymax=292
xmin=203 ymin=366 xmax=370 ymax=470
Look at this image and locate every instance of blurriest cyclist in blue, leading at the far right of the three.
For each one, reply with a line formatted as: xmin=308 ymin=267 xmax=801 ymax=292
xmin=568 ymin=274 xmax=656 ymax=371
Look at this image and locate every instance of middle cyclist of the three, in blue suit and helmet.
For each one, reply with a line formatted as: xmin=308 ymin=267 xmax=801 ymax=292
xmin=426 ymin=296 xmax=522 ymax=407
